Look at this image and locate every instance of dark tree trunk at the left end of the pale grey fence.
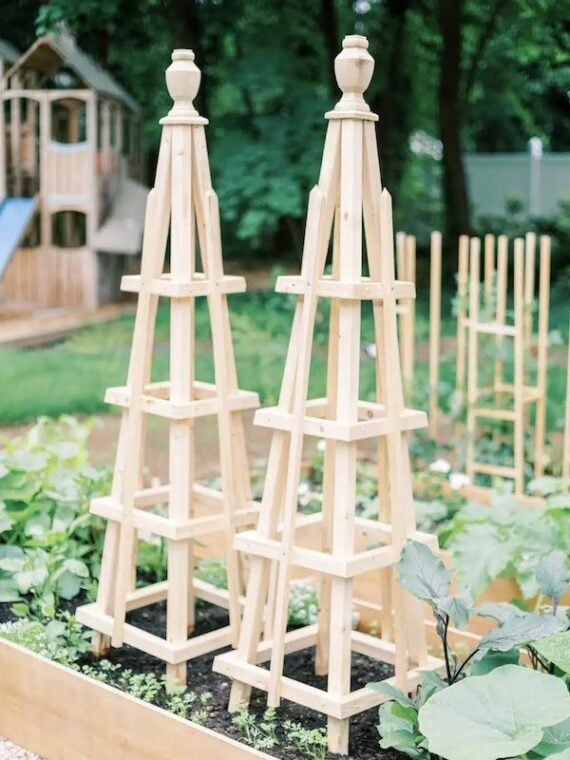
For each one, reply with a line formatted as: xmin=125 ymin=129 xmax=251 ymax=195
xmin=439 ymin=0 xmax=470 ymax=245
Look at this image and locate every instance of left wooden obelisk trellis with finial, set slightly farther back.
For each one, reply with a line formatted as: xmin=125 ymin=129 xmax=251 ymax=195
xmin=78 ymin=50 xmax=258 ymax=682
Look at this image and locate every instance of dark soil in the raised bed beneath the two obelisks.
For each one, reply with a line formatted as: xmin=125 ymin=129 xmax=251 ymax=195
xmin=0 ymin=603 xmax=405 ymax=760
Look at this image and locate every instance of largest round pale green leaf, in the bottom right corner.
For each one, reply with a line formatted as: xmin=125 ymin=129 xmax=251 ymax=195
xmin=419 ymin=665 xmax=570 ymax=760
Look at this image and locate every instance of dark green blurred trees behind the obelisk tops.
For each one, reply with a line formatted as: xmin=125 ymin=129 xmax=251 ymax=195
xmin=2 ymin=0 xmax=570 ymax=268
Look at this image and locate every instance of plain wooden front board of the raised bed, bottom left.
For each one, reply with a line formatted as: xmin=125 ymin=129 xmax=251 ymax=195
xmin=0 ymin=641 xmax=269 ymax=760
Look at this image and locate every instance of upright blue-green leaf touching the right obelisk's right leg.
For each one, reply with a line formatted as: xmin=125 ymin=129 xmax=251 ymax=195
xmin=395 ymin=540 xmax=451 ymax=601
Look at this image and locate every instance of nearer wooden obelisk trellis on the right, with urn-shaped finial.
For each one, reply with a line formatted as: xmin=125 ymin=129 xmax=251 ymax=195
xmin=214 ymin=36 xmax=439 ymax=753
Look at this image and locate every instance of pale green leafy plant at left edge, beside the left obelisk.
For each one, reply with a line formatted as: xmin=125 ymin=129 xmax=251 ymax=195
xmin=0 ymin=417 xmax=109 ymax=618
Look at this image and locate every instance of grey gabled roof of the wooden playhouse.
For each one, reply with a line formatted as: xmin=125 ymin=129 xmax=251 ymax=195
xmin=6 ymin=33 xmax=140 ymax=111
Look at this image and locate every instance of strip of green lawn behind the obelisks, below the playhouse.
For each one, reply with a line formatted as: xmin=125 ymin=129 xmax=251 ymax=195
xmin=0 ymin=291 xmax=565 ymax=429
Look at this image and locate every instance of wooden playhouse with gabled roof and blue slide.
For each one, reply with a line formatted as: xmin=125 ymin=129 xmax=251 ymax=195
xmin=0 ymin=34 xmax=146 ymax=310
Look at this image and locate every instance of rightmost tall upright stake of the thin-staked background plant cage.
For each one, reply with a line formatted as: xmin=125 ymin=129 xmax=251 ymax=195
xmin=534 ymin=235 xmax=550 ymax=478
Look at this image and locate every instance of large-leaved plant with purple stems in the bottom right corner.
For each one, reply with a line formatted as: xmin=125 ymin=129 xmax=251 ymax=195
xmin=369 ymin=541 xmax=570 ymax=760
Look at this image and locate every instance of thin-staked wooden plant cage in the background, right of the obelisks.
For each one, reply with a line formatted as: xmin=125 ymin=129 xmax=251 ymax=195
xmin=457 ymin=232 xmax=550 ymax=495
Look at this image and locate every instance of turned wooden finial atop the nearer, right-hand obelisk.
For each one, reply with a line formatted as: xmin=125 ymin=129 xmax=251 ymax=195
xmin=334 ymin=34 xmax=374 ymax=111
